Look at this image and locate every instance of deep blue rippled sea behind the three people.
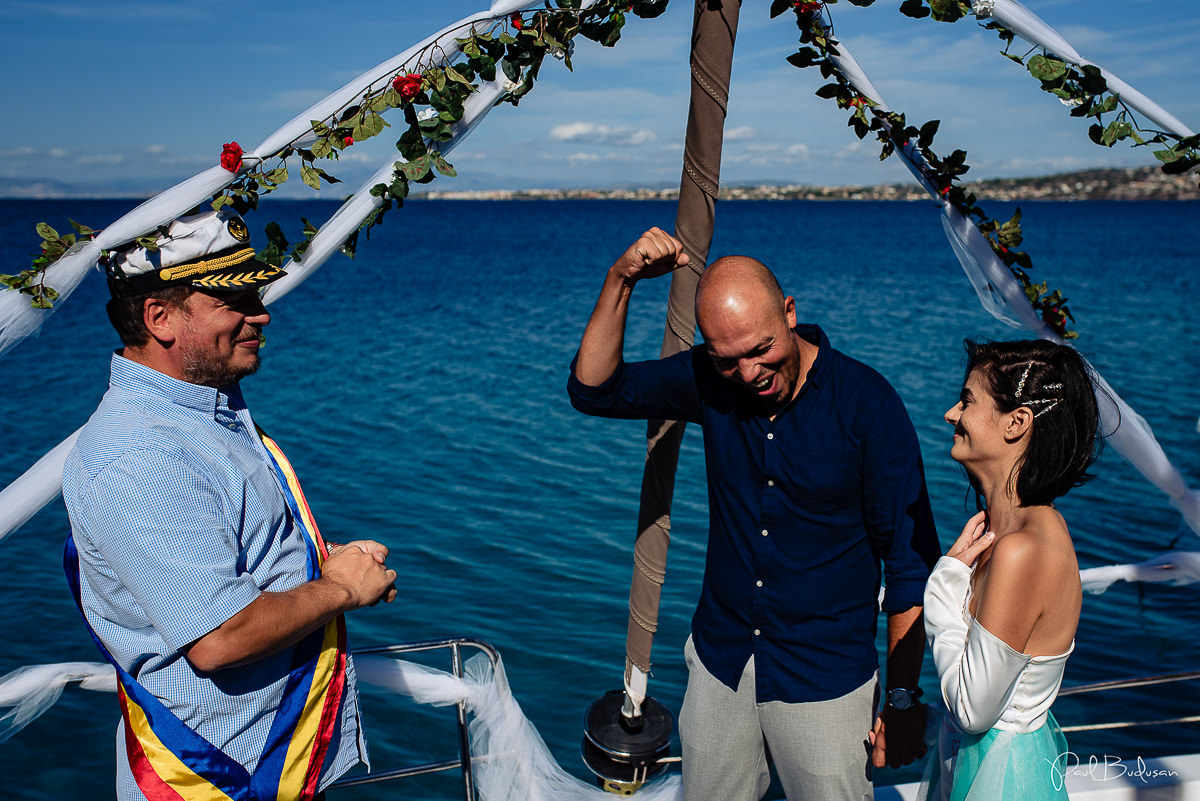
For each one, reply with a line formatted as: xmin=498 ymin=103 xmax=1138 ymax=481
xmin=0 ymin=195 xmax=1200 ymax=800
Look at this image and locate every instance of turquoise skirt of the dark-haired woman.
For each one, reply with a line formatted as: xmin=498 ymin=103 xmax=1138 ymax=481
xmin=920 ymin=715 xmax=1067 ymax=801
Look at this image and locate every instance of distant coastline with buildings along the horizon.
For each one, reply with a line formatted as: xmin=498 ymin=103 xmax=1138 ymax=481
xmin=416 ymin=167 xmax=1200 ymax=200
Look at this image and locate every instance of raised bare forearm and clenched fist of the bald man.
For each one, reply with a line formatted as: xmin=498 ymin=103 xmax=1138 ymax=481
xmin=575 ymin=228 xmax=688 ymax=386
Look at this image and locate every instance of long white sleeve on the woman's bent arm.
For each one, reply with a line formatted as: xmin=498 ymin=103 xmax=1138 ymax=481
xmin=925 ymin=556 xmax=1032 ymax=734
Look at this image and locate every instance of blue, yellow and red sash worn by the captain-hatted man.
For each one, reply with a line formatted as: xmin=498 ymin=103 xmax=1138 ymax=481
xmin=62 ymin=429 xmax=347 ymax=801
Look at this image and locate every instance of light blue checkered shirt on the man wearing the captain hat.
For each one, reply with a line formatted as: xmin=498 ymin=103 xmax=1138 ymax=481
xmin=62 ymin=354 xmax=366 ymax=801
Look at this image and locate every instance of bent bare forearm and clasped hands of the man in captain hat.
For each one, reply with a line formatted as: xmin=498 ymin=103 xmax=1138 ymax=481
xmin=184 ymin=541 xmax=396 ymax=673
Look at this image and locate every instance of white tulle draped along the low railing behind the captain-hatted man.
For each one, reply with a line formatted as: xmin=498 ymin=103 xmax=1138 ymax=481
xmin=0 ymin=654 xmax=683 ymax=801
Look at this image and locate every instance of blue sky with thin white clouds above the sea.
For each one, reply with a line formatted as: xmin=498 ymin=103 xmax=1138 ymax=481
xmin=0 ymin=0 xmax=1200 ymax=197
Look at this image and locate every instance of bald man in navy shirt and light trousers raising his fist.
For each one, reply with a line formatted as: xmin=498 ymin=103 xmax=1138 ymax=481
xmin=568 ymin=228 xmax=941 ymax=801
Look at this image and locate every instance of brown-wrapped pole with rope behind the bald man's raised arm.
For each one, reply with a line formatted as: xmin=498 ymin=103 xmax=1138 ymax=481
xmin=622 ymin=0 xmax=740 ymax=717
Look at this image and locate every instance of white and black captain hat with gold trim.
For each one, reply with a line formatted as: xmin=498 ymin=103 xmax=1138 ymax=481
xmin=104 ymin=209 xmax=287 ymax=297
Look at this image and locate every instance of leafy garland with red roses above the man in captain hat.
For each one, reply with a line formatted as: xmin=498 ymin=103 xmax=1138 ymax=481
xmin=7 ymin=0 xmax=667 ymax=308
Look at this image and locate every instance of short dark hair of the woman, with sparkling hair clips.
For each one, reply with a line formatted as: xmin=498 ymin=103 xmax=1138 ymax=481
xmin=962 ymin=339 xmax=1103 ymax=506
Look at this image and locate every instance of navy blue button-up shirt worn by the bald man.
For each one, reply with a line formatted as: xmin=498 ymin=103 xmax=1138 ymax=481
xmin=568 ymin=325 xmax=941 ymax=703
